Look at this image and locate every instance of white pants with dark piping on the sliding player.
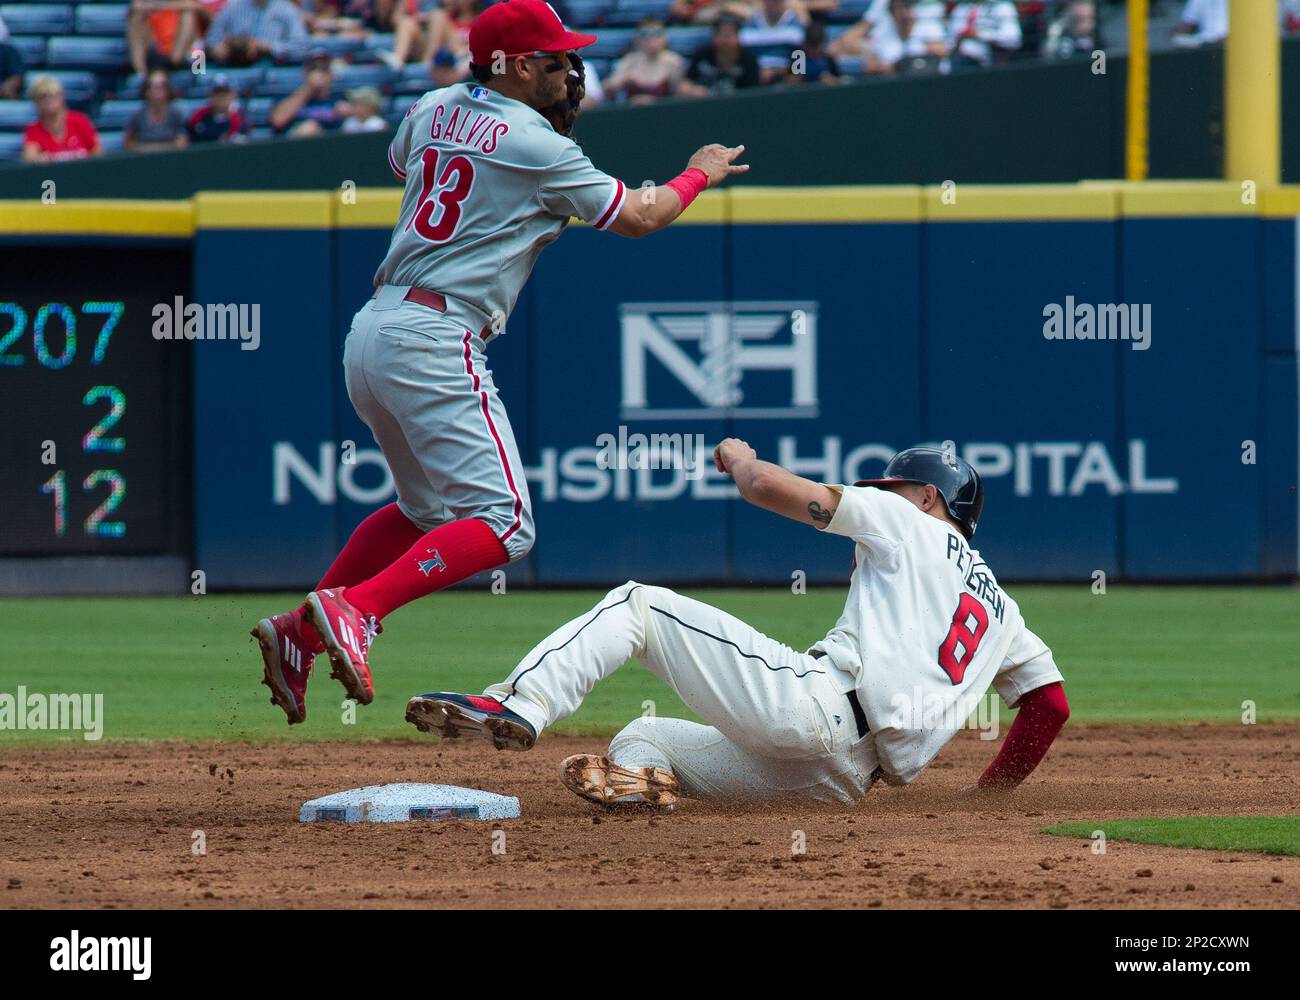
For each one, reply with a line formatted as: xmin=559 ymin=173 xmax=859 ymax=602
xmin=484 ymin=581 xmax=878 ymax=802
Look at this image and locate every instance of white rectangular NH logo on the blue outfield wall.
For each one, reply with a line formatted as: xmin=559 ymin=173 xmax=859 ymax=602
xmin=619 ymin=302 xmax=818 ymax=420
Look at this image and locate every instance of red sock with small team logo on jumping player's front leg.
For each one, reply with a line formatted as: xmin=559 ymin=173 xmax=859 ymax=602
xmin=345 ymin=518 xmax=510 ymax=619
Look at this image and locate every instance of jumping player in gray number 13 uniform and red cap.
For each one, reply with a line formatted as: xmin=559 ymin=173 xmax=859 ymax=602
xmin=252 ymin=0 xmax=749 ymax=724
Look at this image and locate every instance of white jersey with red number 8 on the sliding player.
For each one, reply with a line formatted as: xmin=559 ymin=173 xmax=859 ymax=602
xmin=818 ymin=484 xmax=1062 ymax=783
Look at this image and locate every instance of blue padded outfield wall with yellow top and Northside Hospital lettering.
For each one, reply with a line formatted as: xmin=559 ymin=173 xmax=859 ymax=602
xmin=194 ymin=183 xmax=1300 ymax=588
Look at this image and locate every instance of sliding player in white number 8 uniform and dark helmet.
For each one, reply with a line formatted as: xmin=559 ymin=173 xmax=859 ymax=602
xmin=407 ymin=438 xmax=1069 ymax=809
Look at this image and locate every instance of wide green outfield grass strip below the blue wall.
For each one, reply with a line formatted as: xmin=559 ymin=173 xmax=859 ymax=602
xmin=0 ymin=585 xmax=1300 ymax=744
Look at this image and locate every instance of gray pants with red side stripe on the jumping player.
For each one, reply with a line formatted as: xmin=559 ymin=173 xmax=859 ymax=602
xmin=343 ymin=285 xmax=533 ymax=560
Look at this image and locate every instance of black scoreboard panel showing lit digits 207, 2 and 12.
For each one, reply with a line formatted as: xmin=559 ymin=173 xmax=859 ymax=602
xmin=0 ymin=244 xmax=191 ymax=557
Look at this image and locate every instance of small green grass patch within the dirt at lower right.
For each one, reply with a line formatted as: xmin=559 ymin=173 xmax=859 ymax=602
xmin=1043 ymin=815 xmax=1300 ymax=856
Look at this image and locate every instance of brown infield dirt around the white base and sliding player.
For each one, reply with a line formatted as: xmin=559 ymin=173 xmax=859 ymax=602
xmin=0 ymin=724 xmax=1300 ymax=909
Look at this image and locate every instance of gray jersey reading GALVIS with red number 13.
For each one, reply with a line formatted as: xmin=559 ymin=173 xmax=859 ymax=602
xmin=374 ymin=82 xmax=627 ymax=319
